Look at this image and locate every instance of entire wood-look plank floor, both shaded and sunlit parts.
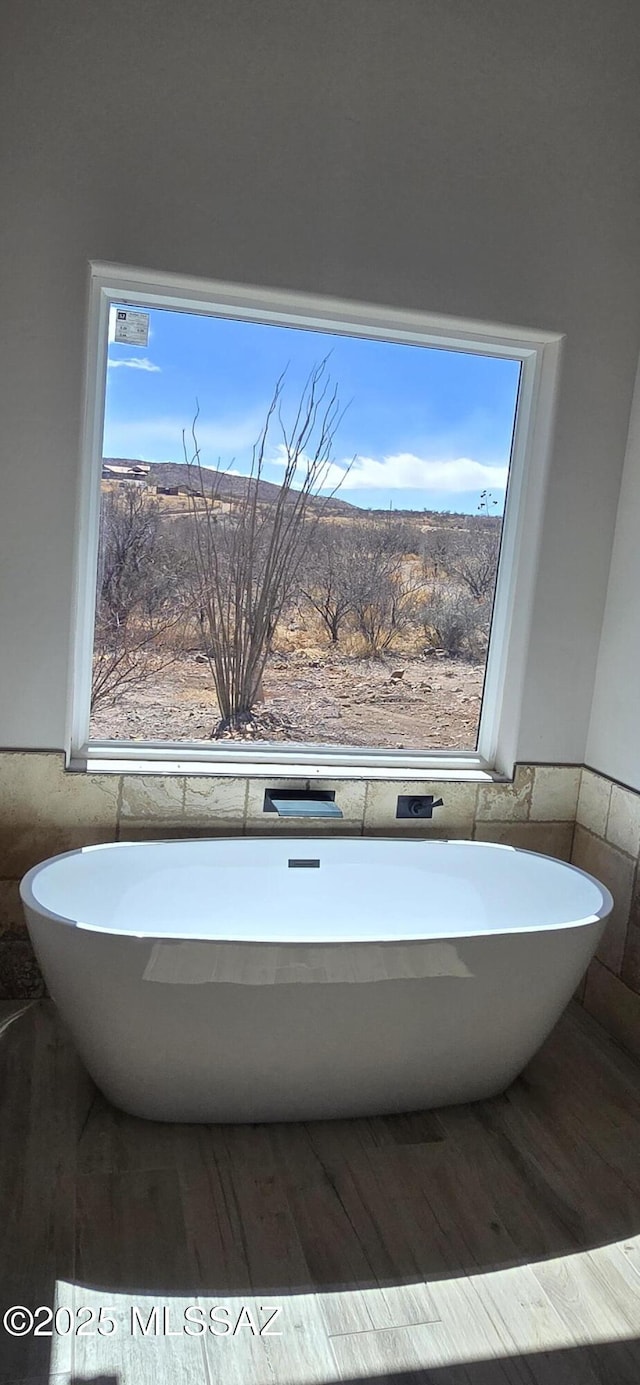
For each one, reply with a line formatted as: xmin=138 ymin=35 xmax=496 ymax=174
xmin=0 ymin=1001 xmax=640 ymax=1385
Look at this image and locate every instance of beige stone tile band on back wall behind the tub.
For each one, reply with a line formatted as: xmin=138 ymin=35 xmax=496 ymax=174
xmin=0 ymin=751 xmax=580 ymax=999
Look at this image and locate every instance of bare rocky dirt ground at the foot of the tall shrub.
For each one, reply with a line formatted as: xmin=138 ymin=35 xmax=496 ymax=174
xmin=91 ymin=651 xmax=485 ymax=751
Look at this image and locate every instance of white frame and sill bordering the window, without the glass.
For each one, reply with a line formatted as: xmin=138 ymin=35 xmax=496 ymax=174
xmin=66 ymin=263 xmax=564 ymax=780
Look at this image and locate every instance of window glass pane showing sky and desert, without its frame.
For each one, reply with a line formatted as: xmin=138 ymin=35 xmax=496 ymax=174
xmin=90 ymin=303 xmax=521 ymax=751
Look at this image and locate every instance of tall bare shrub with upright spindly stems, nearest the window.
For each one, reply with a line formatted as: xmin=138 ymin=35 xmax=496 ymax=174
xmin=184 ymin=360 xmax=347 ymax=735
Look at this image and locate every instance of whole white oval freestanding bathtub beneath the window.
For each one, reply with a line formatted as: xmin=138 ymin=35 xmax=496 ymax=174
xmin=21 ymin=838 xmax=612 ymax=1122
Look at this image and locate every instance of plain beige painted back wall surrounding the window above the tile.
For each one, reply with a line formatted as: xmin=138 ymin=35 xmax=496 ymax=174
xmin=0 ymin=0 xmax=640 ymax=763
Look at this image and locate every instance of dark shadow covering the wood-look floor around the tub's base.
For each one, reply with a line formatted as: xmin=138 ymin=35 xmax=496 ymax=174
xmin=0 ymin=1001 xmax=640 ymax=1385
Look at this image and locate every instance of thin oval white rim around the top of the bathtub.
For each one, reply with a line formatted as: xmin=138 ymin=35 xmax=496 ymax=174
xmin=19 ymin=834 xmax=615 ymax=947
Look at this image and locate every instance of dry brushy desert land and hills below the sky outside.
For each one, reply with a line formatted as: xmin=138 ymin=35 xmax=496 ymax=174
xmin=90 ymin=458 xmax=500 ymax=749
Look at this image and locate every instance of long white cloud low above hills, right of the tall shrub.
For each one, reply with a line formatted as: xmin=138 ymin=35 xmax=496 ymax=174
xmin=272 ymin=445 xmax=508 ymax=494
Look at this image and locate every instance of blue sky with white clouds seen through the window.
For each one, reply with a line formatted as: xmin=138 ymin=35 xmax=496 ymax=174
xmin=104 ymin=309 xmax=519 ymax=512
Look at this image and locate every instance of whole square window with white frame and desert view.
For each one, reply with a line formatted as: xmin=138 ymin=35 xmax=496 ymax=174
xmin=71 ymin=266 xmax=560 ymax=777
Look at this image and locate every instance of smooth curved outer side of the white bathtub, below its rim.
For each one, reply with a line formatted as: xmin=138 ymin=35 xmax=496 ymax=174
xmin=28 ymin=909 xmax=605 ymax=1122
